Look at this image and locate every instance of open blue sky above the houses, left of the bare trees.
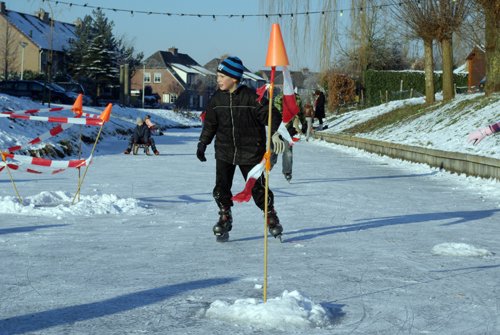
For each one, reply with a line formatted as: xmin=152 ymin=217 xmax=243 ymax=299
xmin=6 ymin=0 xmax=328 ymax=71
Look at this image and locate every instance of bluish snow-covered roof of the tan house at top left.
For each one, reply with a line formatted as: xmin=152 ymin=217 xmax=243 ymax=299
xmin=5 ymin=10 xmax=76 ymax=51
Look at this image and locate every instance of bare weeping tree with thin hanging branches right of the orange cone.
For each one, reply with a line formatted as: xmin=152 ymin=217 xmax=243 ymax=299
xmin=261 ymin=0 xmax=390 ymax=80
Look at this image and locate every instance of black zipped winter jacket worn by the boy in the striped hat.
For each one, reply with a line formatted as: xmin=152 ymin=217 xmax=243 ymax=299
xmin=200 ymin=85 xmax=281 ymax=165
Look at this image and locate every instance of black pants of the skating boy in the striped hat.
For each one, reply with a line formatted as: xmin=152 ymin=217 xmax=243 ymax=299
xmin=213 ymin=159 xmax=274 ymax=210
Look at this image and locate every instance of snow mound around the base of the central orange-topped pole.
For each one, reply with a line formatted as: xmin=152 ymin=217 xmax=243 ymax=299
xmin=205 ymin=291 xmax=332 ymax=331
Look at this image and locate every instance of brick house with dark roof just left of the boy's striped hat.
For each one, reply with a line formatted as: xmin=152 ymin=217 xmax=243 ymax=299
xmin=131 ymin=48 xmax=215 ymax=110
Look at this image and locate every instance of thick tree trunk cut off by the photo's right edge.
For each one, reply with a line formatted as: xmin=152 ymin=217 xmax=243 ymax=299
xmin=483 ymin=2 xmax=500 ymax=95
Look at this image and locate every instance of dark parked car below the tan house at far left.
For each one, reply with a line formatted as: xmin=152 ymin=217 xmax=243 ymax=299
xmin=0 ymin=80 xmax=76 ymax=104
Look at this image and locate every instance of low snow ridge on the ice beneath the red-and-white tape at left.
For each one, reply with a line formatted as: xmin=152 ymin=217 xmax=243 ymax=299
xmin=0 ymin=191 xmax=151 ymax=218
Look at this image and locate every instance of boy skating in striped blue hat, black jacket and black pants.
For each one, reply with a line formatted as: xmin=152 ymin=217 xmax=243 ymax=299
xmin=196 ymin=57 xmax=284 ymax=241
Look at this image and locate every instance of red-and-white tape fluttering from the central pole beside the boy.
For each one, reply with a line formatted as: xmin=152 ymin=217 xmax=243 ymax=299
xmin=232 ymin=66 xmax=299 ymax=202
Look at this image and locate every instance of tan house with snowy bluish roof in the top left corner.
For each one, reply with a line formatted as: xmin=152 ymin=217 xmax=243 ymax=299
xmin=0 ymin=1 xmax=76 ymax=76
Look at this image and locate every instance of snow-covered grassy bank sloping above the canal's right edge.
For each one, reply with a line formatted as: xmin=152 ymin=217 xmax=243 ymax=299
xmin=325 ymin=94 xmax=500 ymax=159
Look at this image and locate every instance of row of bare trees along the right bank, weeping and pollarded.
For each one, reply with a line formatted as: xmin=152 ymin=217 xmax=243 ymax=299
xmin=262 ymin=0 xmax=500 ymax=103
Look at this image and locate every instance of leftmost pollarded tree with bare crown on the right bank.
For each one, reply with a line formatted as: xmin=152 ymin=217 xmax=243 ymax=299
xmin=392 ymin=0 xmax=438 ymax=104
